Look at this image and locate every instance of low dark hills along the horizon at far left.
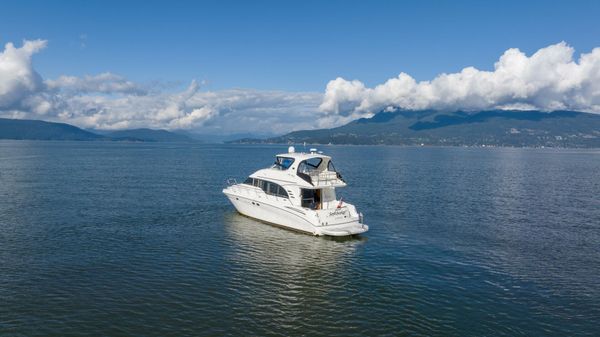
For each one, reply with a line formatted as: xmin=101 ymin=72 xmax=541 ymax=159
xmin=0 ymin=118 xmax=195 ymax=142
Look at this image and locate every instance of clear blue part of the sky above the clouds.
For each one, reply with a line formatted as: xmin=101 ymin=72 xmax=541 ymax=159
xmin=0 ymin=1 xmax=600 ymax=91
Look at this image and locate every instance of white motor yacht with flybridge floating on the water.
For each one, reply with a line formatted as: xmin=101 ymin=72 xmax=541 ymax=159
xmin=223 ymin=146 xmax=369 ymax=236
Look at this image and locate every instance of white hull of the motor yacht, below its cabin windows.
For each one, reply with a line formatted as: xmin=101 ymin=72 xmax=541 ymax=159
xmin=223 ymin=185 xmax=369 ymax=236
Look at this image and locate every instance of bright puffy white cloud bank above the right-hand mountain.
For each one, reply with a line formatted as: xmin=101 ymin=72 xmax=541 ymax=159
xmin=320 ymin=42 xmax=600 ymax=116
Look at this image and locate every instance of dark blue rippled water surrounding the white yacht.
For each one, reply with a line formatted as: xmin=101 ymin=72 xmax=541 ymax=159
xmin=0 ymin=141 xmax=600 ymax=336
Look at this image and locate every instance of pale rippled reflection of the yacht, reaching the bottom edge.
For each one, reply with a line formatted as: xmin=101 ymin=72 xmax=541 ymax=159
xmin=224 ymin=211 xmax=365 ymax=334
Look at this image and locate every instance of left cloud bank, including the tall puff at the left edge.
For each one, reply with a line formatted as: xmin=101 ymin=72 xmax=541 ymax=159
xmin=0 ymin=40 xmax=324 ymax=133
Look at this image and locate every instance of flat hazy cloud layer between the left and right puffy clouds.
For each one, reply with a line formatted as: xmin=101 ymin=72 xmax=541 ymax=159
xmin=45 ymin=81 xmax=322 ymax=133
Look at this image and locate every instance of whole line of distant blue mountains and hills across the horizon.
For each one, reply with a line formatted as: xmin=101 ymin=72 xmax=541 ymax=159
xmin=0 ymin=109 xmax=600 ymax=148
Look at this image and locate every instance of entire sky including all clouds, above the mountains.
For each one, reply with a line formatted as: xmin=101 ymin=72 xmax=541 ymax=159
xmin=0 ymin=0 xmax=600 ymax=133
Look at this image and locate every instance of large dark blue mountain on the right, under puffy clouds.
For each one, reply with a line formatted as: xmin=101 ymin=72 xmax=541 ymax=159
xmin=236 ymin=109 xmax=600 ymax=147
